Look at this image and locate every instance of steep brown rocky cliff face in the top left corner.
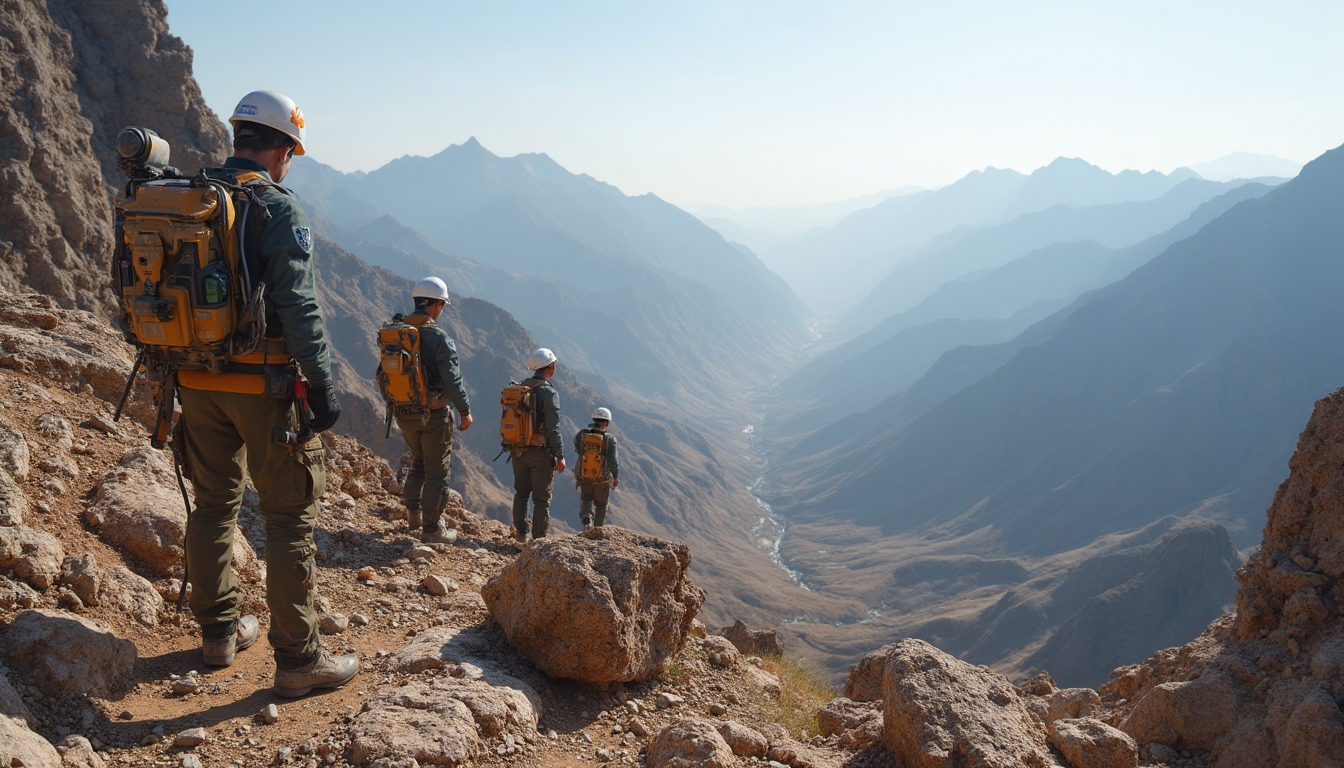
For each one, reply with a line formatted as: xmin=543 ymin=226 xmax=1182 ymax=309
xmin=0 ymin=0 xmax=227 ymax=315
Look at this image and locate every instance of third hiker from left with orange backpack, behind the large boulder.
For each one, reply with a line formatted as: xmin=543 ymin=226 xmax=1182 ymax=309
xmin=500 ymin=347 xmax=564 ymax=543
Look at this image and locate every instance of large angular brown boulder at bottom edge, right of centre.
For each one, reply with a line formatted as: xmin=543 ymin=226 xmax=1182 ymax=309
xmin=882 ymin=639 xmax=1054 ymax=768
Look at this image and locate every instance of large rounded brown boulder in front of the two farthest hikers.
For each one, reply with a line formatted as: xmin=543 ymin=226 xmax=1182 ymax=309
xmin=481 ymin=526 xmax=704 ymax=683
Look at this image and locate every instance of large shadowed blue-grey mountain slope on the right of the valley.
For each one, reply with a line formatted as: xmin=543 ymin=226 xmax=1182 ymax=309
xmin=771 ymin=141 xmax=1344 ymax=554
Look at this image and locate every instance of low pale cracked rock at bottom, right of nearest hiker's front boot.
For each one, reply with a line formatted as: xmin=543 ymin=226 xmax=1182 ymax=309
xmin=351 ymin=627 xmax=542 ymax=765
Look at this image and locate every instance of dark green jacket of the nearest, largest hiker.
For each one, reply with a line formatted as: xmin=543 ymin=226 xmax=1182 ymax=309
xmin=207 ymin=157 xmax=332 ymax=387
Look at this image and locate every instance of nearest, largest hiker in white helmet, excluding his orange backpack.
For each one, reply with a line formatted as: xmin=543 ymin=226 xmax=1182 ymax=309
xmin=177 ymin=90 xmax=359 ymax=697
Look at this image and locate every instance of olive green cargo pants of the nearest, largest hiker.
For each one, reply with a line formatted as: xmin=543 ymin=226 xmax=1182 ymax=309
xmin=181 ymin=389 xmax=327 ymax=658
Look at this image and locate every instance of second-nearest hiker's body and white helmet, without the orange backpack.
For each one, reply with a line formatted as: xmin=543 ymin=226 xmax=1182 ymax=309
xmin=379 ymin=277 xmax=472 ymax=543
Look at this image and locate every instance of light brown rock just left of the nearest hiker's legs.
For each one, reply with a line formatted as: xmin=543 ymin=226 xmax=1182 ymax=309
xmin=85 ymin=445 xmax=186 ymax=576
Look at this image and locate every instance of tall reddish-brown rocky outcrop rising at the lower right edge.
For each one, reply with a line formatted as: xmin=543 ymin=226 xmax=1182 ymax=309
xmin=1101 ymin=390 xmax=1344 ymax=768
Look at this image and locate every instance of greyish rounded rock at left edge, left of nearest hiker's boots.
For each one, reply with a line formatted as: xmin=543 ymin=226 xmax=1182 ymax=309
xmin=3 ymin=609 xmax=136 ymax=695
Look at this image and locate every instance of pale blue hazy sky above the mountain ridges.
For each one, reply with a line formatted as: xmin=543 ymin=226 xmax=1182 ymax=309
xmin=167 ymin=0 xmax=1344 ymax=207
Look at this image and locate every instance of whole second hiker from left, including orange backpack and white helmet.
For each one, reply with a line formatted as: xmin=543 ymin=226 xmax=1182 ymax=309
xmin=378 ymin=277 xmax=472 ymax=543
